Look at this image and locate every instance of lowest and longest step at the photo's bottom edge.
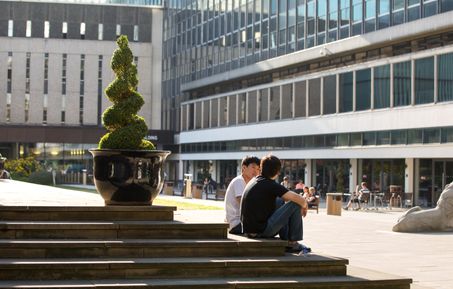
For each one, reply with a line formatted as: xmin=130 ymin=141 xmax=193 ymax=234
xmin=0 ymin=266 xmax=412 ymax=289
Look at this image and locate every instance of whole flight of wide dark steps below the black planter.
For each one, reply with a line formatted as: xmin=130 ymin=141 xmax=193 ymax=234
xmin=0 ymin=206 xmax=412 ymax=289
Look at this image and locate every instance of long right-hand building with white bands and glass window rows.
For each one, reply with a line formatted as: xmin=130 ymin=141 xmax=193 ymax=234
xmin=162 ymin=0 xmax=453 ymax=207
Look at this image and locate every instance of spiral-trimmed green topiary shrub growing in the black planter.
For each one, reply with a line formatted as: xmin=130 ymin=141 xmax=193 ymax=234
xmin=99 ymin=35 xmax=155 ymax=150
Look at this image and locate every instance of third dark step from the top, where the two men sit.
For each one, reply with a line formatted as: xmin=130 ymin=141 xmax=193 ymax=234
xmin=0 ymin=235 xmax=286 ymax=258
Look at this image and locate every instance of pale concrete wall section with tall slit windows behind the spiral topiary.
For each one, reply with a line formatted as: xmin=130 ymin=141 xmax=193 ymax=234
xmin=0 ymin=37 xmax=155 ymax=129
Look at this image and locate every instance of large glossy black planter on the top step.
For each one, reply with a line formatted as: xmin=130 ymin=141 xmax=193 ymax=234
xmin=90 ymin=149 xmax=170 ymax=206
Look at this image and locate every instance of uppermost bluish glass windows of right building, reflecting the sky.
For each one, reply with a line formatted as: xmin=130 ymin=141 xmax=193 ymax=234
xmin=163 ymin=0 xmax=453 ymax=81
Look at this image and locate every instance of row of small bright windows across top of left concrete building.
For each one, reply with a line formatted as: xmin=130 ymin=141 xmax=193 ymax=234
xmin=8 ymin=20 xmax=139 ymax=41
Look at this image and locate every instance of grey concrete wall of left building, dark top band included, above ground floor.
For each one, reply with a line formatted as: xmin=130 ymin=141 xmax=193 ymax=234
xmin=0 ymin=1 xmax=163 ymax=129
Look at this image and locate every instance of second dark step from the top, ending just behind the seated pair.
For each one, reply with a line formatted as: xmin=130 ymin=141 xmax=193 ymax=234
xmin=0 ymin=221 xmax=228 ymax=240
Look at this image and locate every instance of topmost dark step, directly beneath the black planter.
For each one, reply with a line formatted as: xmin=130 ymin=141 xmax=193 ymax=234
xmin=0 ymin=206 xmax=176 ymax=221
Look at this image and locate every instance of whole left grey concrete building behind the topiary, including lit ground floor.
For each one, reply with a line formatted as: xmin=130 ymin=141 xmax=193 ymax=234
xmin=0 ymin=0 xmax=173 ymax=171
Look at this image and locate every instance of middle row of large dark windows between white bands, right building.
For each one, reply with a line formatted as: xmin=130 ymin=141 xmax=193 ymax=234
xmin=181 ymin=49 xmax=453 ymax=131
